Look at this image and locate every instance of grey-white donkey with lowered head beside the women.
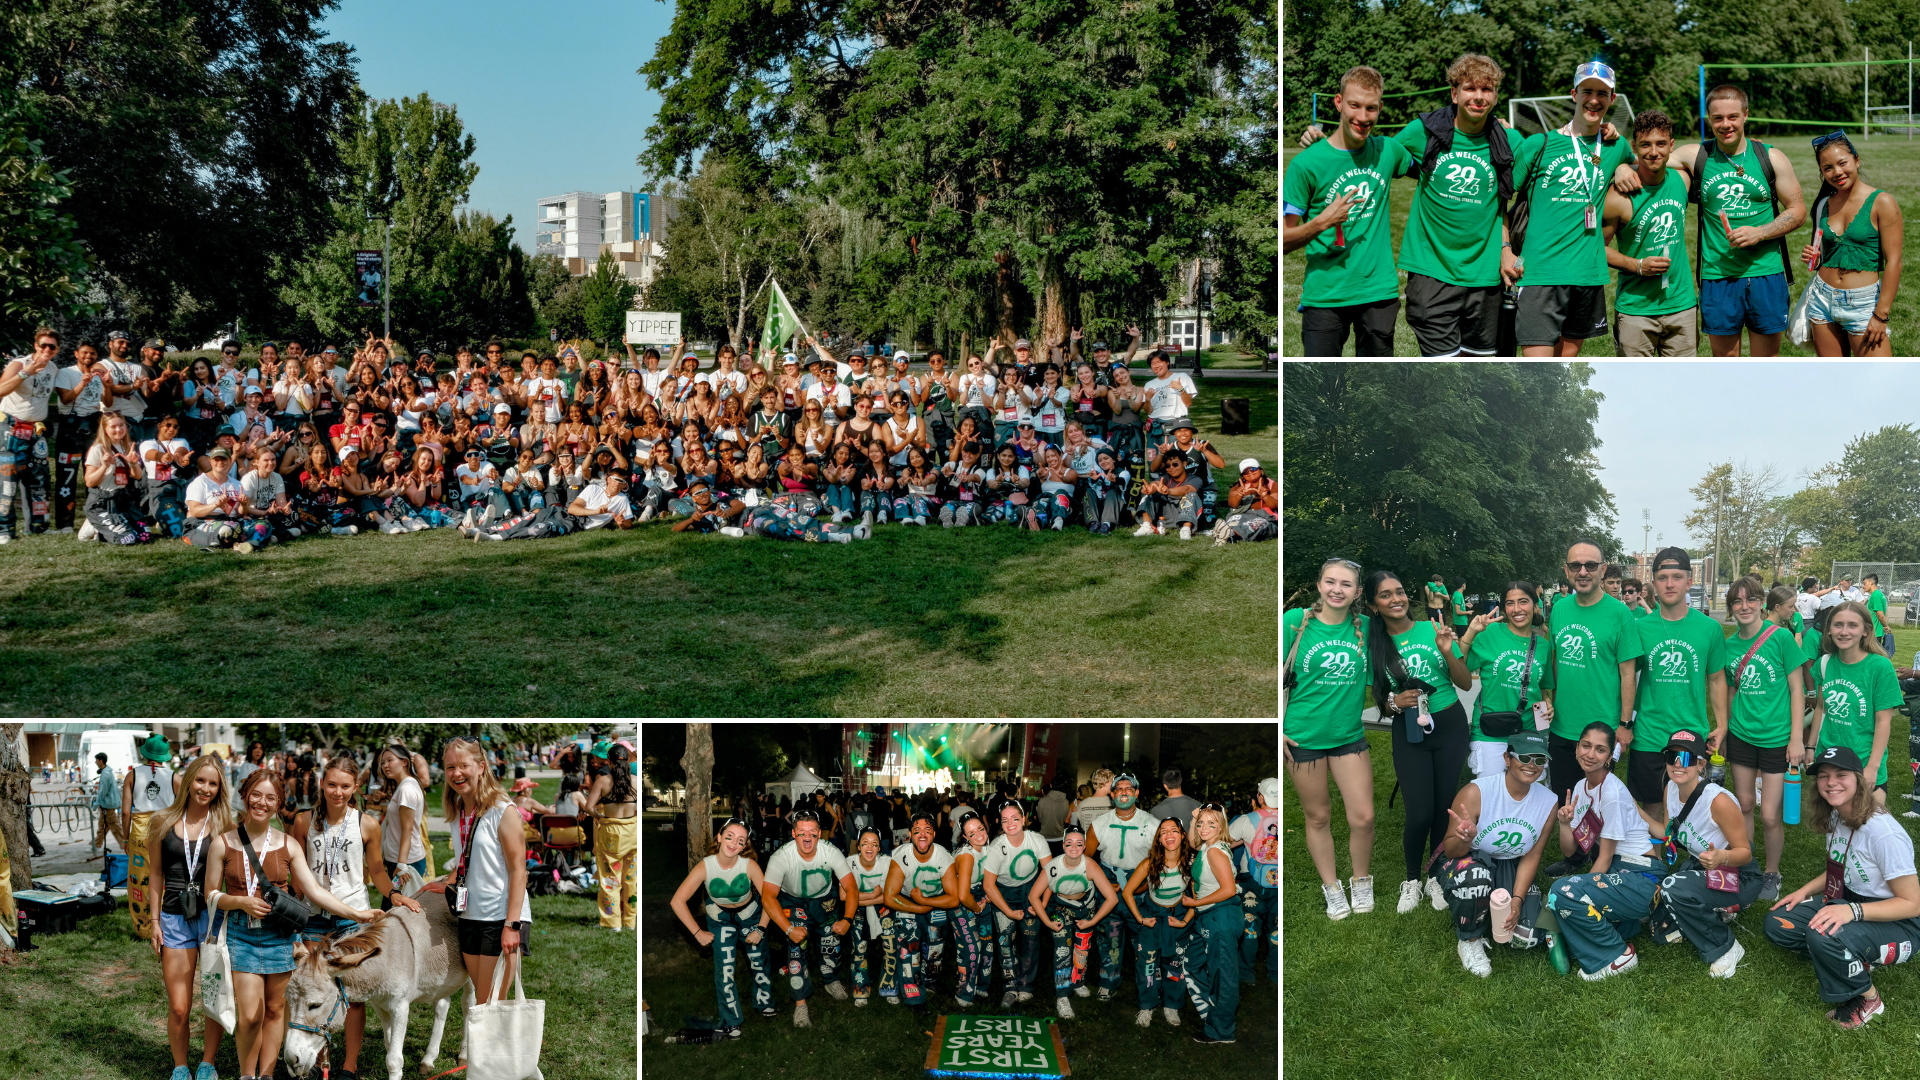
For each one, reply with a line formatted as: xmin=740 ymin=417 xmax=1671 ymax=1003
xmin=286 ymin=896 xmax=467 ymax=1080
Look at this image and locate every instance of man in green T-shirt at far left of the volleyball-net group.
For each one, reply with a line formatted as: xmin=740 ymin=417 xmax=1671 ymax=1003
xmin=1283 ymin=67 xmax=1413 ymax=356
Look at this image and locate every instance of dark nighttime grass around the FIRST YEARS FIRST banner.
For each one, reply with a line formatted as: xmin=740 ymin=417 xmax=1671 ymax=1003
xmin=639 ymin=813 xmax=1279 ymax=1080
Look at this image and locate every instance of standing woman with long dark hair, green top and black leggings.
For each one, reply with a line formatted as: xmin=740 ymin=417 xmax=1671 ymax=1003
xmin=1354 ymin=571 xmax=1473 ymax=915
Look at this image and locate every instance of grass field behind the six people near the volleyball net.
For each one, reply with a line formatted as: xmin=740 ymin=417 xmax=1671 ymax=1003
xmin=1281 ymin=125 xmax=1920 ymax=356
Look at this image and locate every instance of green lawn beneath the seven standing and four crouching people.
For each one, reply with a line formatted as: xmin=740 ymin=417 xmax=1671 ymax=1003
xmin=1281 ymin=628 xmax=1920 ymax=1078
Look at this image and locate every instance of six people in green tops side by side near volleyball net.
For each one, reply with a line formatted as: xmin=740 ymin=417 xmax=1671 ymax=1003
xmin=1283 ymin=54 xmax=1903 ymax=357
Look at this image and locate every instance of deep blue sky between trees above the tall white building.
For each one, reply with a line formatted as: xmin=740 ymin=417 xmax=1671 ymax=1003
xmin=323 ymin=0 xmax=674 ymax=250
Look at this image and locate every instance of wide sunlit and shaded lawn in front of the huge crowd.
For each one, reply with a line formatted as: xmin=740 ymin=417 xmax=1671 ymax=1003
xmin=0 ymin=384 xmax=1279 ymax=717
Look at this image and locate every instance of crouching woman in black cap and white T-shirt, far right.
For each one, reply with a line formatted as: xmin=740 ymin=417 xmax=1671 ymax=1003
xmin=1766 ymin=746 xmax=1920 ymax=1030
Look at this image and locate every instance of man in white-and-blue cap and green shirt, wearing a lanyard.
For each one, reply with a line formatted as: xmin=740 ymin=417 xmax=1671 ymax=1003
xmin=1513 ymin=60 xmax=1632 ymax=356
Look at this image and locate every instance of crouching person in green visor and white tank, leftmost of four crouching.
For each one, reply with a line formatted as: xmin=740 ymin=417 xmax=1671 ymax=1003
xmin=1436 ymin=730 xmax=1555 ymax=978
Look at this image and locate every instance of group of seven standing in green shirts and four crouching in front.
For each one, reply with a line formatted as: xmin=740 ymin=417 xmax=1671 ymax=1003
xmin=1283 ymin=542 xmax=1920 ymax=1028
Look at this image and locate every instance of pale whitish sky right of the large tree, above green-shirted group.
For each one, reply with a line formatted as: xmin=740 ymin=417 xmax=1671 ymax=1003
xmin=1592 ymin=361 xmax=1920 ymax=552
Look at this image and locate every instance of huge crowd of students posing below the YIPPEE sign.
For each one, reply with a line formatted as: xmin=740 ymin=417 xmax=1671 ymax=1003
xmin=0 ymin=327 xmax=1279 ymax=552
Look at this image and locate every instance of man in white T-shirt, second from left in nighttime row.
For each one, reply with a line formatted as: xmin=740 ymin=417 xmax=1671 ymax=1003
xmin=760 ymin=809 xmax=860 ymax=1028
